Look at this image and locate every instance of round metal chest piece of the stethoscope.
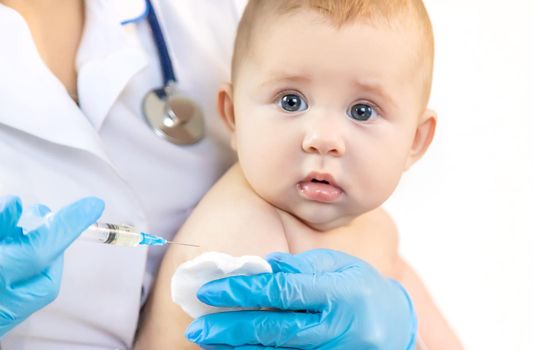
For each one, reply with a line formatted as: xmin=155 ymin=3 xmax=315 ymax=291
xmin=143 ymin=86 xmax=205 ymax=145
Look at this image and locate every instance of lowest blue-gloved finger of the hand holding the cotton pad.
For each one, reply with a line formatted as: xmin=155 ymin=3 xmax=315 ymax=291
xmin=185 ymin=311 xmax=320 ymax=349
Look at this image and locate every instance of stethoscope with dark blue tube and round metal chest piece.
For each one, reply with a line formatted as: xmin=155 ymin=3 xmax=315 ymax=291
xmin=143 ymin=0 xmax=205 ymax=145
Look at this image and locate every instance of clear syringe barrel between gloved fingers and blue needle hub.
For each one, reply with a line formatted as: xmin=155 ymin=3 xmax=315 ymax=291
xmin=80 ymin=223 xmax=142 ymax=247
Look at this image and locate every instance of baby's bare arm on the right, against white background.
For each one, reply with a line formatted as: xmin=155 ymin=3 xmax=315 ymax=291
xmin=394 ymin=258 xmax=463 ymax=350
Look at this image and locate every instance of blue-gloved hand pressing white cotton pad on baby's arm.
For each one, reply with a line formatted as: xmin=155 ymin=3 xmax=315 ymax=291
xmin=186 ymin=249 xmax=417 ymax=350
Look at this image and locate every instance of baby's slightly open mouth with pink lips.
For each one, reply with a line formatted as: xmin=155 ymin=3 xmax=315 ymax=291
xmin=297 ymin=172 xmax=344 ymax=203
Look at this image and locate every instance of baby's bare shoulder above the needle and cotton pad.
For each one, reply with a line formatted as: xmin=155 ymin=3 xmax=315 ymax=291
xmin=176 ymin=164 xmax=288 ymax=256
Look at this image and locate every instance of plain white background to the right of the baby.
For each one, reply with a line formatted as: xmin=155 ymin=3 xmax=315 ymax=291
xmin=385 ymin=0 xmax=533 ymax=350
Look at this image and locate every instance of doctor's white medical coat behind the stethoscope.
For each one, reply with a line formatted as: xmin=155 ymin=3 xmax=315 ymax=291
xmin=0 ymin=0 xmax=244 ymax=350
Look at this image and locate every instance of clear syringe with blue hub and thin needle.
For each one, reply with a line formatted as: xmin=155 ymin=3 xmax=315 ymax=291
xmin=80 ymin=223 xmax=199 ymax=247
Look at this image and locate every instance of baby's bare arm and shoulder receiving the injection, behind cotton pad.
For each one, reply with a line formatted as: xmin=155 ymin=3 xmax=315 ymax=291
xmin=135 ymin=167 xmax=288 ymax=350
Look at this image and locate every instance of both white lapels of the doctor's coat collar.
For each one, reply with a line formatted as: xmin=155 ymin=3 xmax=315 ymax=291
xmin=0 ymin=0 xmax=147 ymax=164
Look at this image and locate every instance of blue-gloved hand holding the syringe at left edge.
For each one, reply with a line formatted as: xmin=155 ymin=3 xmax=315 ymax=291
xmin=0 ymin=196 xmax=104 ymax=337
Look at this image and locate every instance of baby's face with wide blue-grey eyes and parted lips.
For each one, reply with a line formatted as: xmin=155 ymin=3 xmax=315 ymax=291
xmin=229 ymin=11 xmax=432 ymax=230
